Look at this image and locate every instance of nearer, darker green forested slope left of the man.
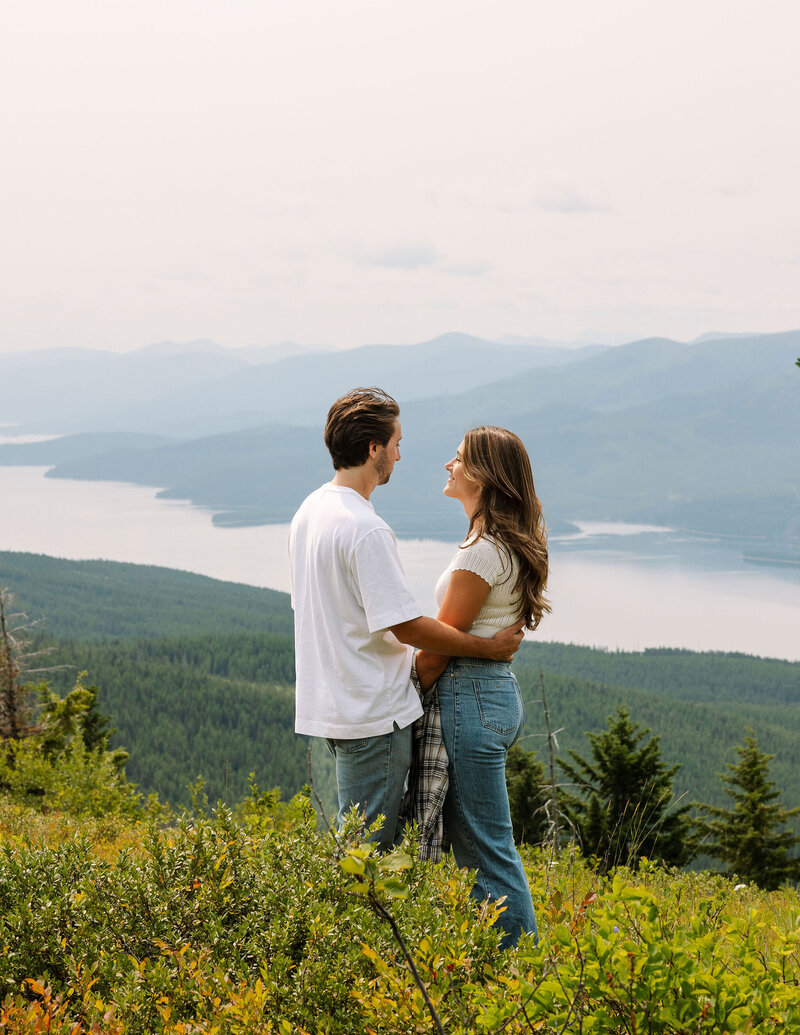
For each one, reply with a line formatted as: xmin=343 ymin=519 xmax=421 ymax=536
xmin=39 ymin=632 xmax=306 ymax=804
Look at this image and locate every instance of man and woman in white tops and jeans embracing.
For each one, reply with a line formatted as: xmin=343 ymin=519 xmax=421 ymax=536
xmin=289 ymin=388 xmax=550 ymax=946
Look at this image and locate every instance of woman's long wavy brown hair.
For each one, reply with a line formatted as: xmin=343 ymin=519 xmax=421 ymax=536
xmin=462 ymin=425 xmax=551 ymax=629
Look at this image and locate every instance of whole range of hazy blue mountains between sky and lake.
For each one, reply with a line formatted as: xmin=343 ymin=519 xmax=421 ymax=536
xmin=0 ymin=331 xmax=800 ymax=549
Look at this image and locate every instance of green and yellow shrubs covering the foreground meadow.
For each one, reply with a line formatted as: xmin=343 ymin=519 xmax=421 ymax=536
xmin=0 ymin=794 xmax=800 ymax=1035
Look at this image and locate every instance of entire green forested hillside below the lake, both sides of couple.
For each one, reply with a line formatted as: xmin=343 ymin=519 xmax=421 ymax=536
xmin=0 ymin=554 xmax=800 ymax=805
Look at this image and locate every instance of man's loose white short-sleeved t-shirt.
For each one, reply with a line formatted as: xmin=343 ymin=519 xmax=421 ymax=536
xmin=289 ymin=482 xmax=422 ymax=740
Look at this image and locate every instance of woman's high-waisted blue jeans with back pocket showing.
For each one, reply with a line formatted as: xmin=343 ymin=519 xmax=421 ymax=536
xmin=437 ymin=657 xmax=536 ymax=948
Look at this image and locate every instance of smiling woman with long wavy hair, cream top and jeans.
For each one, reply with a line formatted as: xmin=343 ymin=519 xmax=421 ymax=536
xmin=416 ymin=426 xmax=551 ymax=947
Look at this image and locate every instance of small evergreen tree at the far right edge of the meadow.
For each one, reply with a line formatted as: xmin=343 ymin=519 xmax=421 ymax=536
xmin=695 ymin=732 xmax=800 ymax=891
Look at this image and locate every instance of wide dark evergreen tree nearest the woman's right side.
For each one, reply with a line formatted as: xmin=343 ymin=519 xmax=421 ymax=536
xmin=559 ymin=708 xmax=691 ymax=871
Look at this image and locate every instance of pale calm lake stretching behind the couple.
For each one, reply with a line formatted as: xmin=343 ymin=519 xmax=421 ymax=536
xmin=0 ymin=467 xmax=800 ymax=660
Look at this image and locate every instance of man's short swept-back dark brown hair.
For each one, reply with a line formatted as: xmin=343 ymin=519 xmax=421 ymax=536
xmin=325 ymin=387 xmax=399 ymax=471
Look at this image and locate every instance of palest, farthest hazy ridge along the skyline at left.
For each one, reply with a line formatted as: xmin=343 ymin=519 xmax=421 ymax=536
xmin=0 ymin=334 xmax=599 ymax=438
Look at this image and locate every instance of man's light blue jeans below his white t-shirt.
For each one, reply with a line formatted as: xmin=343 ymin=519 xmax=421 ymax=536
xmin=327 ymin=722 xmax=413 ymax=852
